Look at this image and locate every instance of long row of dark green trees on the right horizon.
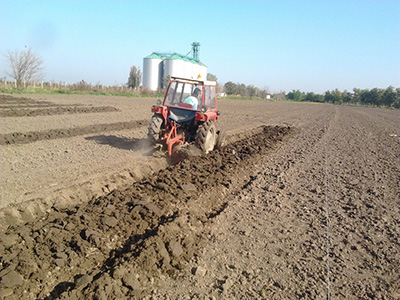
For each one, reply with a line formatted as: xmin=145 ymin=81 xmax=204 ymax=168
xmin=286 ymin=86 xmax=400 ymax=108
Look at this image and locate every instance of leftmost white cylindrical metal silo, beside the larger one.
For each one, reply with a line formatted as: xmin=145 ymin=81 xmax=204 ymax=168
xmin=143 ymin=52 xmax=163 ymax=91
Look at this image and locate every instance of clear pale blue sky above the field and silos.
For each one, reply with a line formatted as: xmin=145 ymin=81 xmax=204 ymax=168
xmin=0 ymin=0 xmax=400 ymax=93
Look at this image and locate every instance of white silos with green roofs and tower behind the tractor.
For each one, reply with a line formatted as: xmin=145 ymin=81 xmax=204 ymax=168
xmin=143 ymin=43 xmax=207 ymax=91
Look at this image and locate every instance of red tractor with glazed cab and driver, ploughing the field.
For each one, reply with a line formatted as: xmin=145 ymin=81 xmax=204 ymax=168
xmin=148 ymin=77 xmax=224 ymax=157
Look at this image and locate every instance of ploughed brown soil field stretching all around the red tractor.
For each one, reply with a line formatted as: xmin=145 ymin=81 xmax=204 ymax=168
xmin=0 ymin=95 xmax=400 ymax=299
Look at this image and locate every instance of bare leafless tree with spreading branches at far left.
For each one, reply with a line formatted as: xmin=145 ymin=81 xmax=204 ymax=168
xmin=5 ymin=48 xmax=44 ymax=89
